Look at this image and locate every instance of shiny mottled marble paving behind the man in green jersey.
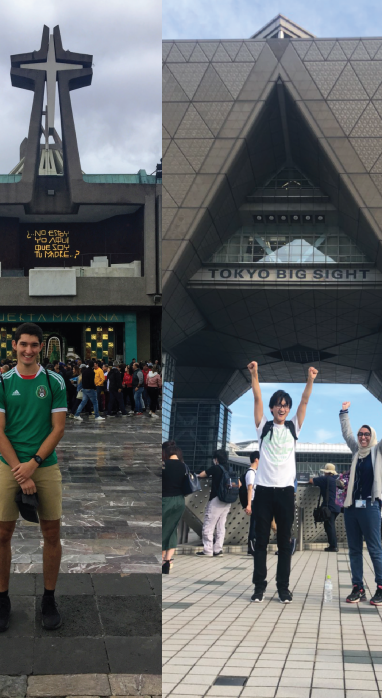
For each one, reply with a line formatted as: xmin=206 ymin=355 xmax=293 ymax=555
xmin=12 ymin=415 xmax=161 ymax=573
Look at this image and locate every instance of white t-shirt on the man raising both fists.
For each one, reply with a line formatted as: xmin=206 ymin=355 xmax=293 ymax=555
xmin=256 ymin=415 xmax=301 ymax=487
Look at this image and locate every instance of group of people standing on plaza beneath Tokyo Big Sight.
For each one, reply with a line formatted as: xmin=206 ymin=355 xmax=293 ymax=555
xmin=162 ymin=361 xmax=382 ymax=606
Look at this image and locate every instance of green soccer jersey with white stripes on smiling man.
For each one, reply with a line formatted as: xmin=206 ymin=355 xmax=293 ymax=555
xmin=0 ymin=366 xmax=67 ymax=468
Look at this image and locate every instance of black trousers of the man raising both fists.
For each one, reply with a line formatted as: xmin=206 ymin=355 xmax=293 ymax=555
xmin=253 ymin=485 xmax=294 ymax=591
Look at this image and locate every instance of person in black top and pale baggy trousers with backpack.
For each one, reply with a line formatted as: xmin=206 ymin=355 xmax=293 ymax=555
xmin=196 ymin=449 xmax=231 ymax=557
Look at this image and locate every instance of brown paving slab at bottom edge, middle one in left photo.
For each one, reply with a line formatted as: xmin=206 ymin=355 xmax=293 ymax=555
xmin=27 ymin=673 xmax=110 ymax=698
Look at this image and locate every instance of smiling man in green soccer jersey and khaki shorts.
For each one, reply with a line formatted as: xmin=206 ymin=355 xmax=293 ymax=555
xmin=0 ymin=323 xmax=67 ymax=632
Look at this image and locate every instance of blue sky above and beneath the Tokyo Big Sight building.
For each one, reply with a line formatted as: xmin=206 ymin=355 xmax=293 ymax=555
xmin=162 ymin=0 xmax=382 ymax=443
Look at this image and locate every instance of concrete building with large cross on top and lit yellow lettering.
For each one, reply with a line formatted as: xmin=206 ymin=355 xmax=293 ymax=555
xmin=0 ymin=27 xmax=161 ymax=362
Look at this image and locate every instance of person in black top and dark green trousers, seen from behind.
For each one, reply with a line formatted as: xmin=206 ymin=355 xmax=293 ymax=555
xmin=162 ymin=442 xmax=186 ymax=574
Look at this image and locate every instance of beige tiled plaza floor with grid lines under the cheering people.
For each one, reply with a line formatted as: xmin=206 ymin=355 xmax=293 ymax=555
xmin=162 ymin=550 xmax=382 ymax=698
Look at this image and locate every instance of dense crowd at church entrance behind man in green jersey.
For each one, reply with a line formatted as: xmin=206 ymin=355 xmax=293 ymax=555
xmin=0 ymin=358 xmax=162 ymax=422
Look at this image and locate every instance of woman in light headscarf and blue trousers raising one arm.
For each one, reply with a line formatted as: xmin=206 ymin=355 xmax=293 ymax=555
xmin=340 ymin=402 xmax=382 ymax=606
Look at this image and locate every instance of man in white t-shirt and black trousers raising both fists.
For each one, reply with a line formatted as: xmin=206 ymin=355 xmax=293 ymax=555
xmin=248 ymin=361 xmax=318 ymax=603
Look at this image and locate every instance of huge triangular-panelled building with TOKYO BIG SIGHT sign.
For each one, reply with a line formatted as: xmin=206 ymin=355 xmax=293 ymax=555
xmin=163 ymin=15 xmax=382 ymax=468
